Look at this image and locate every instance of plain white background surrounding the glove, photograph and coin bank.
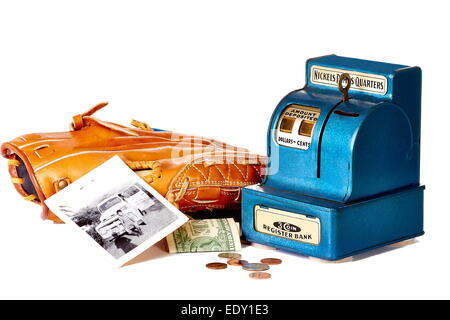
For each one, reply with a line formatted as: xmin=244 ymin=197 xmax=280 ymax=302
xmin=0 ymin=0 xmax=450 ymax=299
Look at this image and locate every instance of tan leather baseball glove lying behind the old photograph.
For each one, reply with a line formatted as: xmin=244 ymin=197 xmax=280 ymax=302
xmin=1 ymin=103 xmax=265 ymax=222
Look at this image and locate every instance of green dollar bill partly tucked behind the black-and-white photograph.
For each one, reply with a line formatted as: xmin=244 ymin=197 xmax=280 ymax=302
xmin=166 ymin=218 xmax=241 ymax=253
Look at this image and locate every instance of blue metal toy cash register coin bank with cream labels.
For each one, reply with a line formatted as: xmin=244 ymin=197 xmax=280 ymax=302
xmin=242 ymin=55 xmax=425 ymax=260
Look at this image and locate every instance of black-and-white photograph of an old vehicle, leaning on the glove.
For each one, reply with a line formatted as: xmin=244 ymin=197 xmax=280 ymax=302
xmin=46 ymin=157 xmax=187 ymax=265
